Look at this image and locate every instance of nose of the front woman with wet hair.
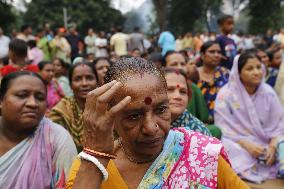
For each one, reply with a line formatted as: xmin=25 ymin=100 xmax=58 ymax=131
xmin=142 ymin=112 xmax=159 ymax=136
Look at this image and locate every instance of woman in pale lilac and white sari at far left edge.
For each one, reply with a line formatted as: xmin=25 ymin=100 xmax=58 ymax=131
xmin=0 ymin=71 xmax=76 ymax=189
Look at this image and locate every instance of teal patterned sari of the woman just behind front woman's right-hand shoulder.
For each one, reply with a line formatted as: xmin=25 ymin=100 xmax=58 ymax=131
xmin=171 ymin=109 xmax=212 ymax=136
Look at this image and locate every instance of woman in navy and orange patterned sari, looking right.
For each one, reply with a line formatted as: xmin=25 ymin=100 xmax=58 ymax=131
xmin=197 ymin=41 xmax=229 ymax=123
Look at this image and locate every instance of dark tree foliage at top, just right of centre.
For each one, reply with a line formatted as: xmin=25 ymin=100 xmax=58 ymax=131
xmin=153 ymin=0 xmax=222 ymax=34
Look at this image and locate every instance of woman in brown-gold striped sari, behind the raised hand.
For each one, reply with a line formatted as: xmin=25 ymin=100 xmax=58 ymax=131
xmin=49 ymin=63 xmax=97 ymax=151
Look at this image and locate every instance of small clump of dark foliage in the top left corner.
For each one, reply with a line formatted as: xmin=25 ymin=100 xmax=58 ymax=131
xmin=0 ymin=1 xmax=16 ymax=31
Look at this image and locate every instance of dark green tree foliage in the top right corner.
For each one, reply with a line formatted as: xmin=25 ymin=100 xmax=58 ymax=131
xmin=248 ymin=0 xmax=282 ymax=34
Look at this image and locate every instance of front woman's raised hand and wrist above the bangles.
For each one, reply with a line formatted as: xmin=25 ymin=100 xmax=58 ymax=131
xmin=83 ymin=81 xmax=131 ymax=153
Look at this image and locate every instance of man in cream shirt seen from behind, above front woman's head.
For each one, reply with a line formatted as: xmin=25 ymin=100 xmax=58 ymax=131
xmin=110 ymin=27 xmax=128 ymax=56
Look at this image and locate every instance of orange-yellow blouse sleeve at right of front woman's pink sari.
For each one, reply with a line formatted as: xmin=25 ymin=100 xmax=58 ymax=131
xmin=217 ymin=157 xmax=250 ymax=189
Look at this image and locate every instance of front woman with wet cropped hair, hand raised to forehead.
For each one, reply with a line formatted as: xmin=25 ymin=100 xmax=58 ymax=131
xmin=67 ymin=58 xmax=248 ymax=189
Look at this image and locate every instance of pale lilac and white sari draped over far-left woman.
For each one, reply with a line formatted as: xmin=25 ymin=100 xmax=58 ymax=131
xmin=0 ymin=118 xmax=76 ymax=189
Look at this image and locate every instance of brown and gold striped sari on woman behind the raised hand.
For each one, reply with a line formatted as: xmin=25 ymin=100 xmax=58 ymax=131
xmin=49 ymin=97 xmax=83 ymax=152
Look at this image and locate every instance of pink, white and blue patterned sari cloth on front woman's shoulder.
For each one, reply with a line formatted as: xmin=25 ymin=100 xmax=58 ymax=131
xmin=135 ymin=128 xmax=227 ymax=189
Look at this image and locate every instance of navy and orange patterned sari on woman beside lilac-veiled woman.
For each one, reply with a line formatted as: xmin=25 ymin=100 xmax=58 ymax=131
xmin=197 ymin=67 xmax=229 ymax=121
